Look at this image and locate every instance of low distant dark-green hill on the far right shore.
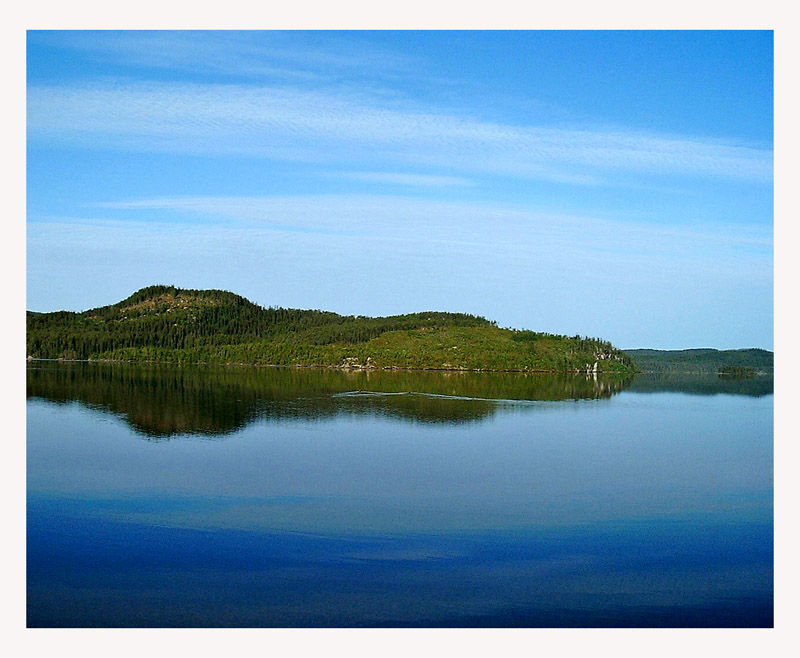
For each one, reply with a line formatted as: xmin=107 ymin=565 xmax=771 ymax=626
xmin=625 ymin=348 xmax=775 ymax=374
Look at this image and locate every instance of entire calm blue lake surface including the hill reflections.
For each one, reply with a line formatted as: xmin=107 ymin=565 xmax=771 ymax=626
xmin=27 ymin=362 xmax=773 ymax=627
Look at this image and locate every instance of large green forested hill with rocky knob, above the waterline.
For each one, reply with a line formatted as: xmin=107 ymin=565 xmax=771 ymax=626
xmin=27 ymin=286 xmax=635 ymax=372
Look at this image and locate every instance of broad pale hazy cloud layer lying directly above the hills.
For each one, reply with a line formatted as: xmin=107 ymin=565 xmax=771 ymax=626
xmin=27 ymin=195 xmax=773 ymax=348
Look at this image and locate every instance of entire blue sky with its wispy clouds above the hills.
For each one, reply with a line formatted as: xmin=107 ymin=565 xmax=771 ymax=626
xmin=27 ymin=31 xmax=773 ymax=349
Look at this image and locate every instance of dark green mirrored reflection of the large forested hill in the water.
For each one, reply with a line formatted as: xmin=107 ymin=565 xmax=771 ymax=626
xmin=27 ymin=361 xmax=629 ymax=438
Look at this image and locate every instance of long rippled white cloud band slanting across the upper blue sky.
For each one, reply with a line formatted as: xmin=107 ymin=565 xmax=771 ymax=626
xmin=28 ymin=83 xmax=772 ymax=184
